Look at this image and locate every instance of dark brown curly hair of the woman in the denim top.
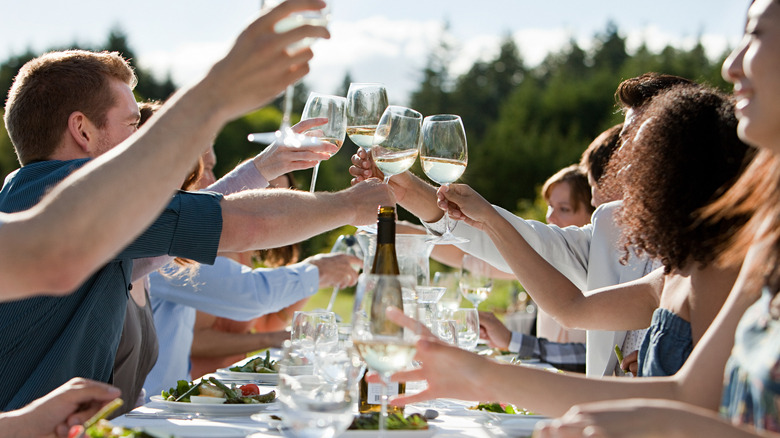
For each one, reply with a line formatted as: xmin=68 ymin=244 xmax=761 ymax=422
xmin=605 ymin=85 xmax=754 ymax=273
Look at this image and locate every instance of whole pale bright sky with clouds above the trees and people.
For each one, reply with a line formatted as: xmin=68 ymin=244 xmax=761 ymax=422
xmin=0 ymin=0 xmax=748 ymax=103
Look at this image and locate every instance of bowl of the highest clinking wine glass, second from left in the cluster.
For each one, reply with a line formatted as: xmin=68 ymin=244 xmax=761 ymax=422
xmin=347 ymin=82 xmax=387 ymax=152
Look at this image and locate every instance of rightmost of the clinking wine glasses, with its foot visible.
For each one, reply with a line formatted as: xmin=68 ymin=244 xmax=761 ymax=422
xmin=420 ymin=114 xmax=468 ymax=244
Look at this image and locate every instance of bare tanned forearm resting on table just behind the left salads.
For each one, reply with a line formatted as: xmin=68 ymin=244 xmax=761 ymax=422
xmin=190 ymin=328 xmax=289 ymax=357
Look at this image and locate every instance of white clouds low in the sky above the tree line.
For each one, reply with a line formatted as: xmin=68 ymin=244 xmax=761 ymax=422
xmin=139 ymin=16 xmax=736 ymax=104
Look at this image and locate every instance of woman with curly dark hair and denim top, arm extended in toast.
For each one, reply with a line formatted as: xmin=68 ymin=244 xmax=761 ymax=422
xmin=430 ymin=84 xmax=752 ymax=376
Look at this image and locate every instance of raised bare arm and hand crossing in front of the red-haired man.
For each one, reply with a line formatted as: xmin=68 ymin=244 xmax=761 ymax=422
xmin=0 ymin=0 xmax=328 ymax=300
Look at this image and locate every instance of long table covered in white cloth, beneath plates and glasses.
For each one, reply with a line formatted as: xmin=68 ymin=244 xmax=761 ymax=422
xmin=111 ymin=354 xmax=554 ymax=438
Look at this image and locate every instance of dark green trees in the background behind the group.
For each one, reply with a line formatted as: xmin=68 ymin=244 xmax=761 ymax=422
xmin=0 ymin=23 xmax=728 ymax=308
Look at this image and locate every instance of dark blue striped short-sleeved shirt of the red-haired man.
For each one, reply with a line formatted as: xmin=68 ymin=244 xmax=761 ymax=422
xmin=0 ymin=160 xmax=222 ymax=410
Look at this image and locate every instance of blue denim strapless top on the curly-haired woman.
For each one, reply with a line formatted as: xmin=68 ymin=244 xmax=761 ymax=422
xmin=637 ymin=308 xmax=693 ymax=377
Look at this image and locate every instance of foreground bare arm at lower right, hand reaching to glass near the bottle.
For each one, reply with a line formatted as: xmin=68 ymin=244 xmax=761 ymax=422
xmin=388 ymin=246 xmax=757 ymax=415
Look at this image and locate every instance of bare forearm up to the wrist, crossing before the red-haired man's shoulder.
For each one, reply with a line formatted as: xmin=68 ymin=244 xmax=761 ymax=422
xmin=0 ymin=81 xmax=223 ymax=299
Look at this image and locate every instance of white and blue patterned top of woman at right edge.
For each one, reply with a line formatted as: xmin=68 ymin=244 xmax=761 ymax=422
xmin=720 ymin=288 xmax=780 ymax=432
